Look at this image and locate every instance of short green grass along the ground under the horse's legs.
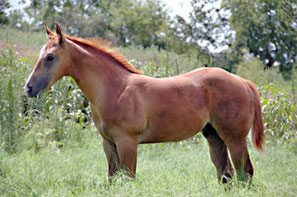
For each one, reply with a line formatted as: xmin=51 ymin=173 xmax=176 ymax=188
xmin=0 ymin=128 xmax=297 ymax=196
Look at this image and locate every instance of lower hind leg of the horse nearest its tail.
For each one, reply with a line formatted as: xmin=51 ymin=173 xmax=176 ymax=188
xmin=227 ymin=139 xmax=254 ymax=181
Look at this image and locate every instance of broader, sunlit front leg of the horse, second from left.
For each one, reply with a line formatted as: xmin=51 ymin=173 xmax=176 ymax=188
xmin=116 ymin=136 xmax=138 ymax=178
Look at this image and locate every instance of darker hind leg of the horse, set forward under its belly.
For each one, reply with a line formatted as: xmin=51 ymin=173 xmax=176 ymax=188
xmin=202 ymin=123 xmax=233 ymax=183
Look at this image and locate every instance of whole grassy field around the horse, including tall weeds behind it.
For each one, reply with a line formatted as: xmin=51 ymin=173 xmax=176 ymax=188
xmin=0 ymin=29 xmax=297 ymax=196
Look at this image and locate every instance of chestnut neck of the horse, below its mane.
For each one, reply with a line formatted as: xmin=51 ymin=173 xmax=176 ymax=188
xmin=69 ymin=42 xmax=130 ymax=106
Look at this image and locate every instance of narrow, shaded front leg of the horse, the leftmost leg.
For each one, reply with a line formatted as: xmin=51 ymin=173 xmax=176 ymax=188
xmin=103 ymin=139 xmax=120 ymax=180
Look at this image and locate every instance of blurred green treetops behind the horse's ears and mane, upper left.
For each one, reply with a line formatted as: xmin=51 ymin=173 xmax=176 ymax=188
xmin=5 ymin=0 xmax=210 ymax=57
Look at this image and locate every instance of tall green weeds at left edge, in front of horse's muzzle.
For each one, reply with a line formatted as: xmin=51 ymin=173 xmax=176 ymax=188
xmin=0 ymin=47 xmax=28 ymax=152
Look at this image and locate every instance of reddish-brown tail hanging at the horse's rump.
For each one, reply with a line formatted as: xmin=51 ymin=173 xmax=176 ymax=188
xmin=246 ymin=80 xmax=265 ymax=152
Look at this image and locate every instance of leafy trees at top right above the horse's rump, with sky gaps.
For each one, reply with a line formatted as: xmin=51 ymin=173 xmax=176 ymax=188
xmin=174 ymin=0 xmax=297 ymax=79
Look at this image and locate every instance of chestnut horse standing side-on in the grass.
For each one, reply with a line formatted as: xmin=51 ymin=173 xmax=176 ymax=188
xmin=25 ymin=24 xmax=265 ymax=182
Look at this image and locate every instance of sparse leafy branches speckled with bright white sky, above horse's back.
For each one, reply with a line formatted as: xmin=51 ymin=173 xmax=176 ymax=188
xmin=177 ymin=0 xmax=232 ymax=49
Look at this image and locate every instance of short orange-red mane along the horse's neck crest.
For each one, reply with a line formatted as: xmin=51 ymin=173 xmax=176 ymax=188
xmin=65 ymin=35 xmax=143 ymax=74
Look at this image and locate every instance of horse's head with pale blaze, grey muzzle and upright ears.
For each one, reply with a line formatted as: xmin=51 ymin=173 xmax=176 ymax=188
xmin=25 ymin=23 xmax=69 ymax=97
